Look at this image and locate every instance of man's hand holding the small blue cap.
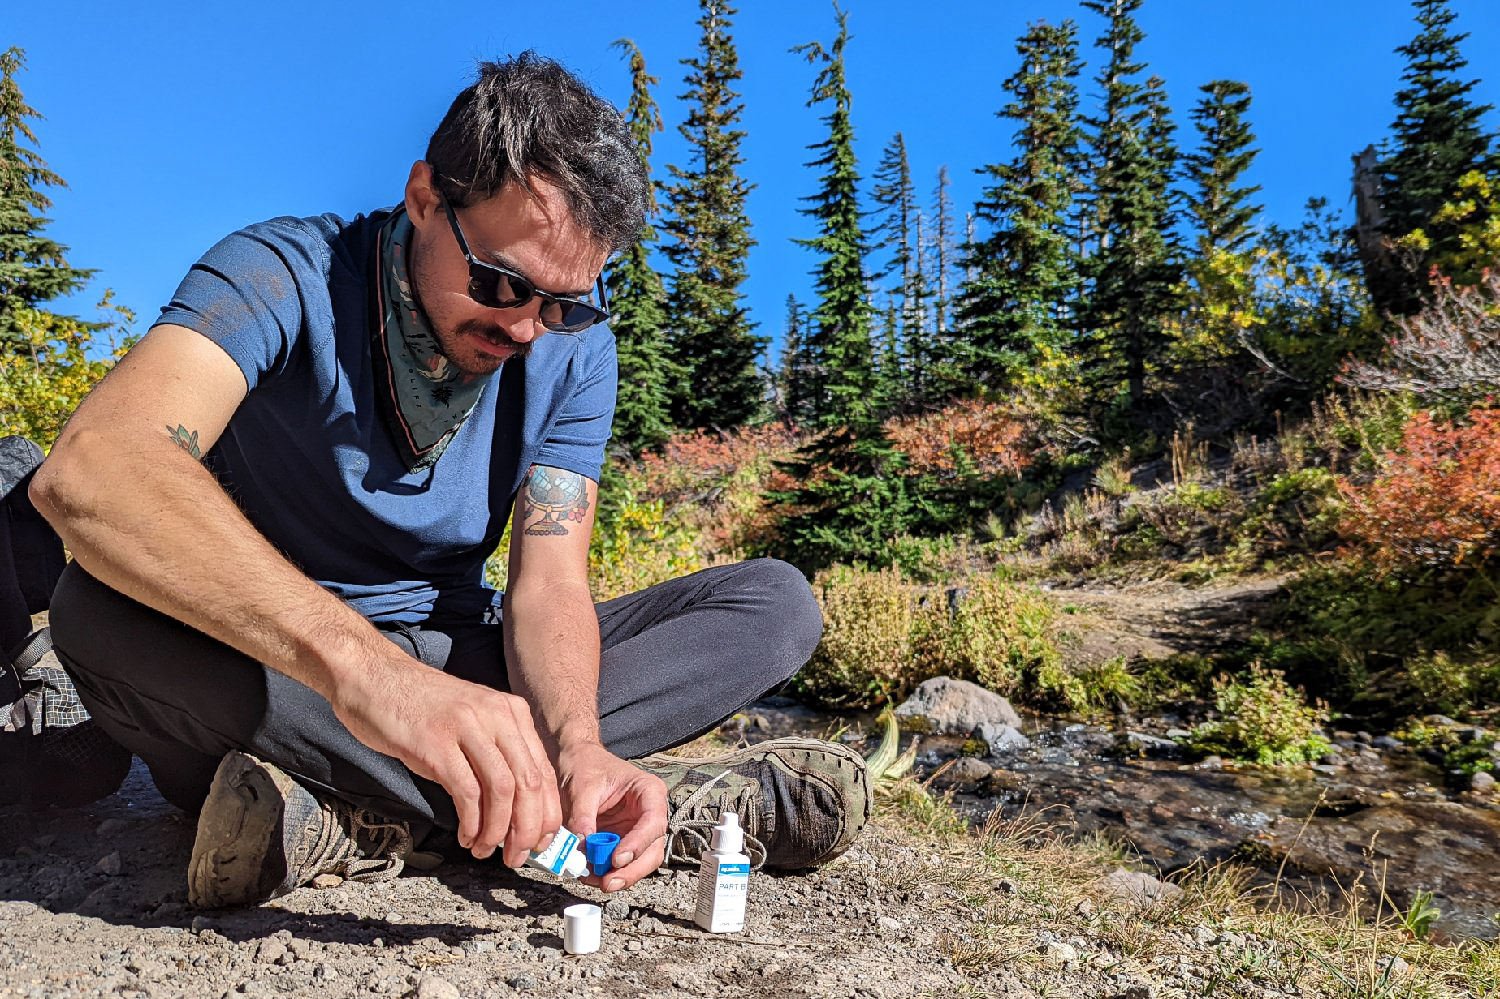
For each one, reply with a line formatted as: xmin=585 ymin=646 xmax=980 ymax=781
xmin=558 ymin=743 xmax=668 ymax=891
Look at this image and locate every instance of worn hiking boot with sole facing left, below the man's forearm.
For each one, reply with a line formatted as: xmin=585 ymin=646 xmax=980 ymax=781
xmin=188 ymin=750 xmax=413 ymax=909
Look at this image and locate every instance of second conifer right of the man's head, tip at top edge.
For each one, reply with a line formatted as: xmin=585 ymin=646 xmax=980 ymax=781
xmin=662 ymin=0 xmax=765 ymax=429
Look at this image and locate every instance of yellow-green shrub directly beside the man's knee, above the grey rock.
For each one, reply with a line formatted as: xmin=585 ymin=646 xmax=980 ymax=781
xmin=792 ymin=566 xmax=923 ymax=708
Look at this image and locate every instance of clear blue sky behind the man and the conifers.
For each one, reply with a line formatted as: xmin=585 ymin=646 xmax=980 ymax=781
xmin=0 ymin=0 xmax=1500 ymax=352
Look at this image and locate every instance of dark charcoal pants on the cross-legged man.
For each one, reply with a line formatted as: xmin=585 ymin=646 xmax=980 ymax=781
xmin=51 ymin=560 xmax=822 ymax=831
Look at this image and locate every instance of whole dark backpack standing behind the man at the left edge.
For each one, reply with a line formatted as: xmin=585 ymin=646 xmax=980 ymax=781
xmin=0 ymin=437 xmax=131 ymax=807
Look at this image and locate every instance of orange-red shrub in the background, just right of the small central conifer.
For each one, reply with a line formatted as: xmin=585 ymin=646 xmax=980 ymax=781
xmin=885 ymin=399 xmax=1031 ymax=479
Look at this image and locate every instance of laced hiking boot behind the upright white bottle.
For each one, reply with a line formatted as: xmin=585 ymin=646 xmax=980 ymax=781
xmin=635 ymin=738 xmax=875 ymax=870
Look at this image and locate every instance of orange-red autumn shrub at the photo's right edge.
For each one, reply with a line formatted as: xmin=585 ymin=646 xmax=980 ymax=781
xmin=1338 ymin=408 xmax=1500 ymax=570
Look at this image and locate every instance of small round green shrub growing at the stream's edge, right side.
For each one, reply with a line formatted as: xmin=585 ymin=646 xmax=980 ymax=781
xmin=1191 ymin=665 xmax=1331 ymax=767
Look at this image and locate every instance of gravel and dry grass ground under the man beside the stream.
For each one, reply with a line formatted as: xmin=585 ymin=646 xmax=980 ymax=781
xmin=0 ymin=756 xmax=1500 ymax=999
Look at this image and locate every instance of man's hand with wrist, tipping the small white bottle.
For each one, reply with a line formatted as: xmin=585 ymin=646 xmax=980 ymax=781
xmin=333 ymin=660 xmax=564 ymax=867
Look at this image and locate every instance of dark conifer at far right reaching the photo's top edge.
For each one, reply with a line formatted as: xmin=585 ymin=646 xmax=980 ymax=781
xmin=1370 ymin=0 xmax=1497 ymax=315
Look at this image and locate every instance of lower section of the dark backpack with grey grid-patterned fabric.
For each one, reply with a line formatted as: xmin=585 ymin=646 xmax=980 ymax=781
xmin=0 ymin=629 xmax=131 ymax=807
